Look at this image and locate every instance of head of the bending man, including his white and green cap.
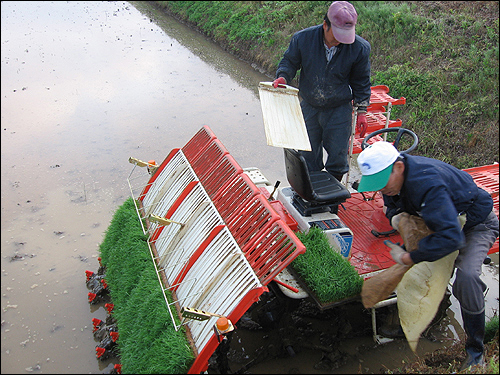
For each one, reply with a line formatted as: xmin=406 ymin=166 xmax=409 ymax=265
xmin=358 ymin=141 xmax=405 ymax=196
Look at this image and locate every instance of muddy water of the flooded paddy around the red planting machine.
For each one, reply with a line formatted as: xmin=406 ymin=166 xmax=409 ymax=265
xmin=1 ymin=2 xmax=498 ymax=373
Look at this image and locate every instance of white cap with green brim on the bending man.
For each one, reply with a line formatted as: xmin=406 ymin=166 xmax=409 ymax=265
xmin=357 ymin=141 xmax=399 ymax=192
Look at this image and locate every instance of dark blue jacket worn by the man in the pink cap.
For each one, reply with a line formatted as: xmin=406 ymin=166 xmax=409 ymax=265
xmin=276 ymin=25 xmax=371 ymax=108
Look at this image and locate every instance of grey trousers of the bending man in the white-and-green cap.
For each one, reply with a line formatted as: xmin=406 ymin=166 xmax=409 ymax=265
xmin=453 ymin=211 xmax=498 ymax=315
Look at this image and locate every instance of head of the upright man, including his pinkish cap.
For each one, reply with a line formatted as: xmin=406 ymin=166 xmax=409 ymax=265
xmin=326 ymin=1 xmax=358 ymax=44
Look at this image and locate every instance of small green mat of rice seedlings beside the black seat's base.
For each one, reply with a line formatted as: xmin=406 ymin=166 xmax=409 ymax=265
xmin=288 ymin=227 xmax=363 ymax=309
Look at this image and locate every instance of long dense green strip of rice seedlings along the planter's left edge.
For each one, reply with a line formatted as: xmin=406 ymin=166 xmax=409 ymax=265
xmin=99 ymin=198 xmax=194 ymax=374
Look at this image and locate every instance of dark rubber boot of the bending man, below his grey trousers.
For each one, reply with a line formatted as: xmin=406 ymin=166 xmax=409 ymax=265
xmin=460 ymin=309 xmax=485 ymax=371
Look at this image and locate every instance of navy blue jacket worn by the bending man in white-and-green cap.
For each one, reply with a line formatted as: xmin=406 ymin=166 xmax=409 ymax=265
xmin=384 ymin=154 xmax=493 ymax=263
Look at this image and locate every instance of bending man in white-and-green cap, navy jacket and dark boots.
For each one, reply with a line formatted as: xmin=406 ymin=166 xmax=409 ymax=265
xmin=358 ymin=142 xmax=499 ymax=369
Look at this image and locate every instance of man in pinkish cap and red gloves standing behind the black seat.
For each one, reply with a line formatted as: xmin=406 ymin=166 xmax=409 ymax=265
xmin=273 ymin=1 xmax=371 ymax=181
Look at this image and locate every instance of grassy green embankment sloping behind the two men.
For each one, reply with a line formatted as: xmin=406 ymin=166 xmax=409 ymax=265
xmin=155 ymin=1 xmax=499 ymax=169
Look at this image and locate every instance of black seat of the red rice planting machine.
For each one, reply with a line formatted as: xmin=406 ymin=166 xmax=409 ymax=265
xmin=284 ymin=148 xmax=351 ymax=216
